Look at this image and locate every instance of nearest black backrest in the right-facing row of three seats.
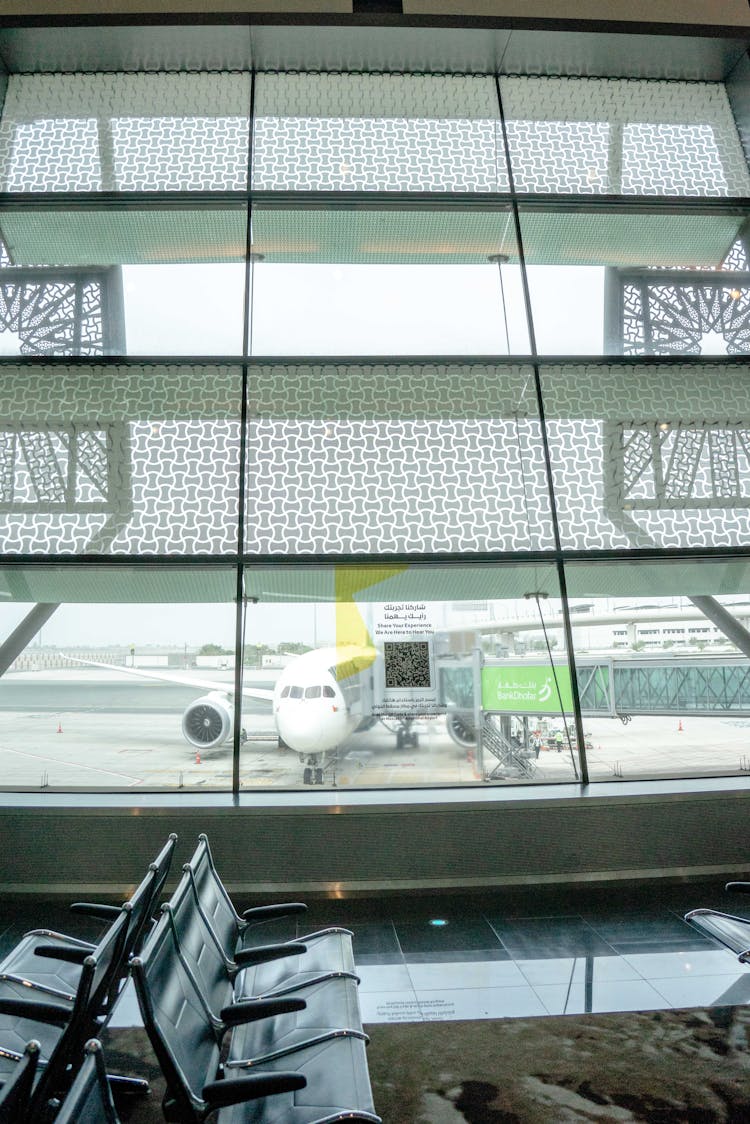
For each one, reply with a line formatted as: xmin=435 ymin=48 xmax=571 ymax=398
xmin=130 ymin=910 xmax=219 ymax=1124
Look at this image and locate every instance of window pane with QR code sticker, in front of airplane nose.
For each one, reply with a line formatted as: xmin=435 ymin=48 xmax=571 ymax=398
xmin=242 ymin=565 xmax=579 ymax=787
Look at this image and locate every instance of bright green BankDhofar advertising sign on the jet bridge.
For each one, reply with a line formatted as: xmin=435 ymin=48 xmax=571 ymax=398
xmin=481 ymin=663 xmax=573 ymax=714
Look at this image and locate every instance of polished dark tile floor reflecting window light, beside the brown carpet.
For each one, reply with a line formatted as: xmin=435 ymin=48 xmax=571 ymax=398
xmin=0 ymin=880 xmax=750 ymax=1025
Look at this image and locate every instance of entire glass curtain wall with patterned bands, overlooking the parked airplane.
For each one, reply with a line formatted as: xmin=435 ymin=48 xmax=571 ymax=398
xmin=0 ymin=65 xmax=750 ymax=791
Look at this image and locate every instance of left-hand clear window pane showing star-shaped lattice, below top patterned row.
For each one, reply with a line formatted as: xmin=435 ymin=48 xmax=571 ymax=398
xmin=0 ymin=207 xmax=246 ymax=355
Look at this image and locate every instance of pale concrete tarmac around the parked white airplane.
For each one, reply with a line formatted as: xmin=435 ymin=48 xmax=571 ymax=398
xmin=0 ymin=669 xmax=750 ymax=790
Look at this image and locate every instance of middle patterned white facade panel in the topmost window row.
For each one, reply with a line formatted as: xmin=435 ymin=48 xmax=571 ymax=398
xmin=252 ymin=74 xmax=508 ymax=191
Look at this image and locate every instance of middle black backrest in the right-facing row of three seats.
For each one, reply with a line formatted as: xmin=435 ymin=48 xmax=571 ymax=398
xmin=163 ymin=871 xmax=234 ymax=1021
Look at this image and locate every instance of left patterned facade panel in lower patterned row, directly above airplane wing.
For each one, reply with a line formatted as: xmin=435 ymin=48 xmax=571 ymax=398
xmin=0 ymin=365 xmax=242 ymax=555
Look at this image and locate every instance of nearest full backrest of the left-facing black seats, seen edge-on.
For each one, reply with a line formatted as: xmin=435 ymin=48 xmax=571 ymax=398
xmin=29 ymin=909 xmax=128 ymax=1121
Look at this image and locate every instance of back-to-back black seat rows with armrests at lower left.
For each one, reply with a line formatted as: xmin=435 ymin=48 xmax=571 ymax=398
xmin=0 ymin=836 xmax=380 ymax=1124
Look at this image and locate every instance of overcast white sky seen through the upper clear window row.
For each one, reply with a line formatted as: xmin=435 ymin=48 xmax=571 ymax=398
xmin=123 ymin=263 xmax=604 ymax=356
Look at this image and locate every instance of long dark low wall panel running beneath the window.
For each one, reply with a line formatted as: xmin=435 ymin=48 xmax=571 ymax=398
xmin=0 ymin=791 xmax=750 ymax=894
